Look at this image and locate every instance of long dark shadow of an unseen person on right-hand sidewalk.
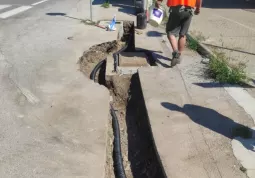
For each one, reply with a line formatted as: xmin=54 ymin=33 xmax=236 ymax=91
xmin=161 ymin=102 xmax=254 ymax=151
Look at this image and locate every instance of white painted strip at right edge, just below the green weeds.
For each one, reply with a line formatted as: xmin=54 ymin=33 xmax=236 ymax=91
xmin=224 ymin=85 xmax=255 ymax=123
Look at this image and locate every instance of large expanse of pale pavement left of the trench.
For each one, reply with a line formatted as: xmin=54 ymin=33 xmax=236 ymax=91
xmin=0 ymin=0 xmax=114 ymax=178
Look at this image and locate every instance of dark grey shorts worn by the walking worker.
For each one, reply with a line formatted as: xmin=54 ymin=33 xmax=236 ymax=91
xmin=166 ymin=6 xmax=193 ymax=36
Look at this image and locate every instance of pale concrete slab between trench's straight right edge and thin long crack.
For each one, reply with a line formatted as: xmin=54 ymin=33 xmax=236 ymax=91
xmin=139 ymin=67 xmax=218 ymax=177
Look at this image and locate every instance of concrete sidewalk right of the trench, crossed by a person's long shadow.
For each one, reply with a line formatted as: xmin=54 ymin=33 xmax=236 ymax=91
xmin=136 ymin=21 xmax=255 ymax=178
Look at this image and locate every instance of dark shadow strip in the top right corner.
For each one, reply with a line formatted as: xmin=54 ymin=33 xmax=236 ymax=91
xmin=203 ymin=0 xmax=255 ymax=9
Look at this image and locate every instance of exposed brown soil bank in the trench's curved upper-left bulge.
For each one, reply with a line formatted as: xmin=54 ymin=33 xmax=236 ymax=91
xmin=79 ymin=40 xmax=125 ymax=76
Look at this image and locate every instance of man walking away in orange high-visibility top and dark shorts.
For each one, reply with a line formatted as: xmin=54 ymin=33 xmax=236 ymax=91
xmin=155 ymin=0 xmax=202 ymax=67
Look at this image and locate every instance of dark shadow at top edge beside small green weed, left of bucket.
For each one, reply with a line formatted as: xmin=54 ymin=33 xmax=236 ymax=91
xmin=92 ymin=0 xmax=135 ymax=15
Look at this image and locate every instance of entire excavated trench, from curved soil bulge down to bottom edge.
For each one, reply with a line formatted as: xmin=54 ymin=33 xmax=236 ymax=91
xmin=80 ymin=22 xmax=165 ymax=178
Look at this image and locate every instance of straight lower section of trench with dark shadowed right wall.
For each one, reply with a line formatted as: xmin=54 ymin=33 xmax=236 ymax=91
xmin=103 ymin=74 xmax=164 ymax=178
